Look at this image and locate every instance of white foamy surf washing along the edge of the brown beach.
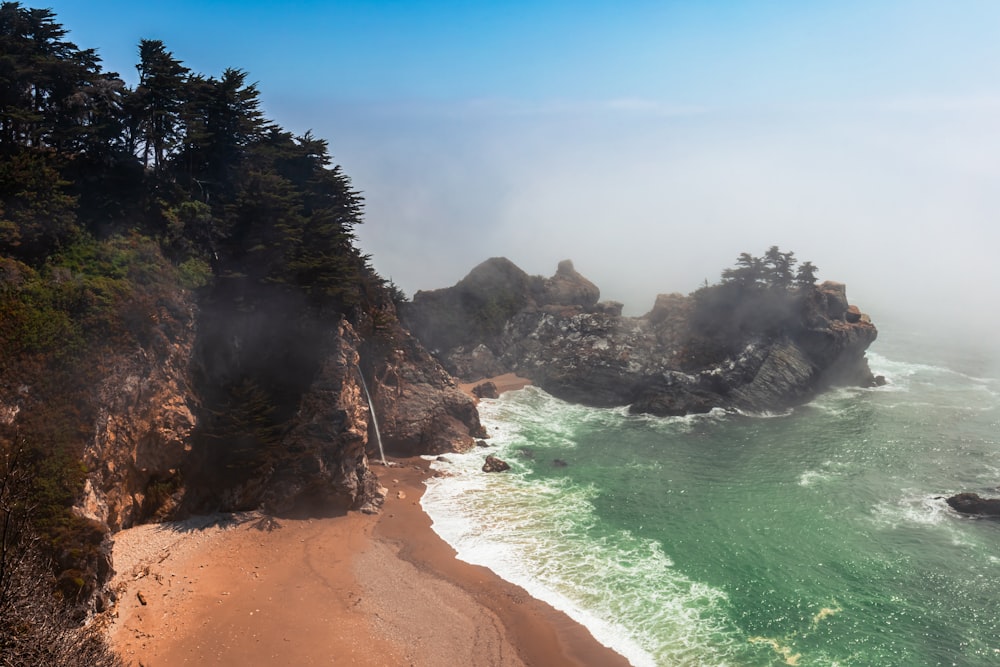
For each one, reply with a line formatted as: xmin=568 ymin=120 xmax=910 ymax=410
xmin=422 ymin=441 xmax=737 ymax=666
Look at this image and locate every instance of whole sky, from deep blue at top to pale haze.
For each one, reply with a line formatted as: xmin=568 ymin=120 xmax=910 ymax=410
xmin=35 ymin=0 xmax=1000 ymax=350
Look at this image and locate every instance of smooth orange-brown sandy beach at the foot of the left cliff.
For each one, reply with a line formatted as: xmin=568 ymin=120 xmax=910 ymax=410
xmin=108 ymin=459 xmax=628 ymax=667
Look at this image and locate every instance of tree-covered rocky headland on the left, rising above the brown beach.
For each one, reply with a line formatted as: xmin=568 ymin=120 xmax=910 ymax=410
xmin=0 ymin=2 xmax=483 ymax=665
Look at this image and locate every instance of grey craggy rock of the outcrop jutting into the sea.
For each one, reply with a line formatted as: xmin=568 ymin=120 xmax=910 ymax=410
xmin=404 ymin=259 xmax=877 ymax=415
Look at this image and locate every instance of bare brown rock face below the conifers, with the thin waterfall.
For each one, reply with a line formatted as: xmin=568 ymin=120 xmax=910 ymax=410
xmin=70 ymin=293 xmax=482 ymax=531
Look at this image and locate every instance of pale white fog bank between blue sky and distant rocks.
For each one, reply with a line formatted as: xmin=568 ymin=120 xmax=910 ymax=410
xmin=280 ymin=93 xmax=1000 ymax=360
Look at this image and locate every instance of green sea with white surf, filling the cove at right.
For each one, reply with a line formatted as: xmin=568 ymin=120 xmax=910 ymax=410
xmin=423 ymin=346 xmax=1000 ymax=667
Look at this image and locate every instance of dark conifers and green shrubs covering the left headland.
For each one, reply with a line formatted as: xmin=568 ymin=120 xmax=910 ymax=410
xmin=0 ymin=2 xmax=406 ymax=664
